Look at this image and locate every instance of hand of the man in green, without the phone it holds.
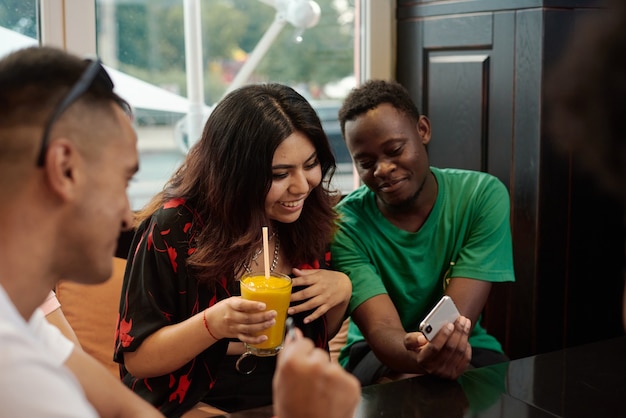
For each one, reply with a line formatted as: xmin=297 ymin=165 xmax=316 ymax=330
xmin=404 ymin=316 xmax=472 ymax=379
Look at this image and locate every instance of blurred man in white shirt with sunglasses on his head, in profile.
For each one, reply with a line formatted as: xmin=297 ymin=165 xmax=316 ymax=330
xmin=0 ymin=48 xmax=160 ymax=417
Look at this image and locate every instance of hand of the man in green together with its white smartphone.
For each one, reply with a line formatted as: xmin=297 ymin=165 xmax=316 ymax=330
xmin=404 ymin=296 xmax=472 ymax=379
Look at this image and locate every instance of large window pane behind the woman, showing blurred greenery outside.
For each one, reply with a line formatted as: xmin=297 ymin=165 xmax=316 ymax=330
xmin=96 ymin=0 xmax=355 ymax=209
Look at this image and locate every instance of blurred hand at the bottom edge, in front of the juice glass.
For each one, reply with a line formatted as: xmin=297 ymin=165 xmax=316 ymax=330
xmin=272 ymin=329 xmax=361 ymax=418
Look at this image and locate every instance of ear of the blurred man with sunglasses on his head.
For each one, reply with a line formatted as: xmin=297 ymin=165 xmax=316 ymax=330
xmin=44 ymin=138 xmax=80 ymax=200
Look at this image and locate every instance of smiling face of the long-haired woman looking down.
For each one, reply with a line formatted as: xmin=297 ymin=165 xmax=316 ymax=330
xmin=265 ymin=131 xmax=322 ymax=223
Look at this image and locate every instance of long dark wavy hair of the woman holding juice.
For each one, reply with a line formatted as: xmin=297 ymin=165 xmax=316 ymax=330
xmin=136 ymin=84 xmax=337 ymax=283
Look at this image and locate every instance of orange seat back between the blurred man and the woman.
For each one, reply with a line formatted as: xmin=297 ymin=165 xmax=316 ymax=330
xmin=56 ymin=258 xmax=126 ymax=377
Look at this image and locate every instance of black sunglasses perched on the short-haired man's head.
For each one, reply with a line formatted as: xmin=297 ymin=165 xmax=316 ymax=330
xmin=37 ymin=59 xmax=113 ymax=167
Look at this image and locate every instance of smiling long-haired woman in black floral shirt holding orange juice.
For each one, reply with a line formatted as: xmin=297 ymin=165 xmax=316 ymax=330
xmin=115 ymin=84 xmax=352 ymax=416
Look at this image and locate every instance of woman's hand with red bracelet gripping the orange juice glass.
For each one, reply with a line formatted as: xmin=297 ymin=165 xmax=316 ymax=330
xmin=204 ymin=296 xmax=276 ymax=344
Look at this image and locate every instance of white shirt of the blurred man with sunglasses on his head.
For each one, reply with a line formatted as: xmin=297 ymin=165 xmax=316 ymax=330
xmin=0 ymin=286 xmax=98 ymax=418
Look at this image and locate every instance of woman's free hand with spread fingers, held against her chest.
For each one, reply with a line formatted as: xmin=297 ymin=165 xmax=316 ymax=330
xmin=288 ymin=269 xmax=352 ymax=324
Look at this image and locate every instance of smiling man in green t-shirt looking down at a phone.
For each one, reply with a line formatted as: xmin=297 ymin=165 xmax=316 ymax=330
xmin=332 ymin=80 xmax=515 ymax=385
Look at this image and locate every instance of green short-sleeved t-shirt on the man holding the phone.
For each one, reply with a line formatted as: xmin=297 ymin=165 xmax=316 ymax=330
xmin=331 ymin=167 xmax=515 ymax=366
